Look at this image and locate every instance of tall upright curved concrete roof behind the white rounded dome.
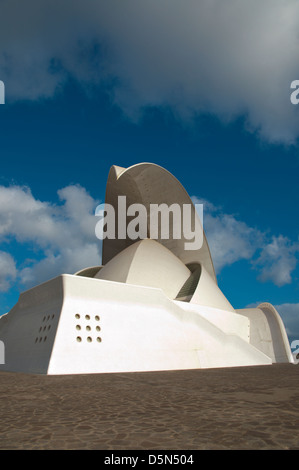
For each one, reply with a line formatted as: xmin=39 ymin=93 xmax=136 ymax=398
xmin=102 ymin=163 xmax=217 ymax=282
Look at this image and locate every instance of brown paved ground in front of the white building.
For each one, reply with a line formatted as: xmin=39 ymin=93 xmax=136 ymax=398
xmin=0 ymin=364 xmax=299 ymax=450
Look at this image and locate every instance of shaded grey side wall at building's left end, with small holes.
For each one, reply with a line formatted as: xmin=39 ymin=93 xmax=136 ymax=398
xmin=0 ymin=277 xmax=63 ymax=374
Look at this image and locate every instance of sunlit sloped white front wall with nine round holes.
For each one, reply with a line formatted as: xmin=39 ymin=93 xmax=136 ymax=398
xmin=48 ymin=275 xmax=271 ymax=374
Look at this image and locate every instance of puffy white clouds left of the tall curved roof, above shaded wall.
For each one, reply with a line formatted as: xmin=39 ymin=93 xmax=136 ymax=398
xmin=0 ymin=186 xmax=100 ymax=290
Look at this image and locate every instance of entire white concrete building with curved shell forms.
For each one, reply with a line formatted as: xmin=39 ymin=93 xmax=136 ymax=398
xmin=0 ymin=163 xmax=293 ymax=374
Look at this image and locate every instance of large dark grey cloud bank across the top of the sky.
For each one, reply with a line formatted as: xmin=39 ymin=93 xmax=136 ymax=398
xmin=0 ymin=0 xmax=299 ymax=143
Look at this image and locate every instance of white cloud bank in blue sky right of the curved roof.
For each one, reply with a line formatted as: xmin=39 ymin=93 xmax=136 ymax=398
xmin=192 ymin=196 xmax=299 ymax=286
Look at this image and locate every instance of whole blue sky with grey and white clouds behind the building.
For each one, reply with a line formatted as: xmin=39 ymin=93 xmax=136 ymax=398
xmin=0 ymin=0 xmax=299 ymax=346
